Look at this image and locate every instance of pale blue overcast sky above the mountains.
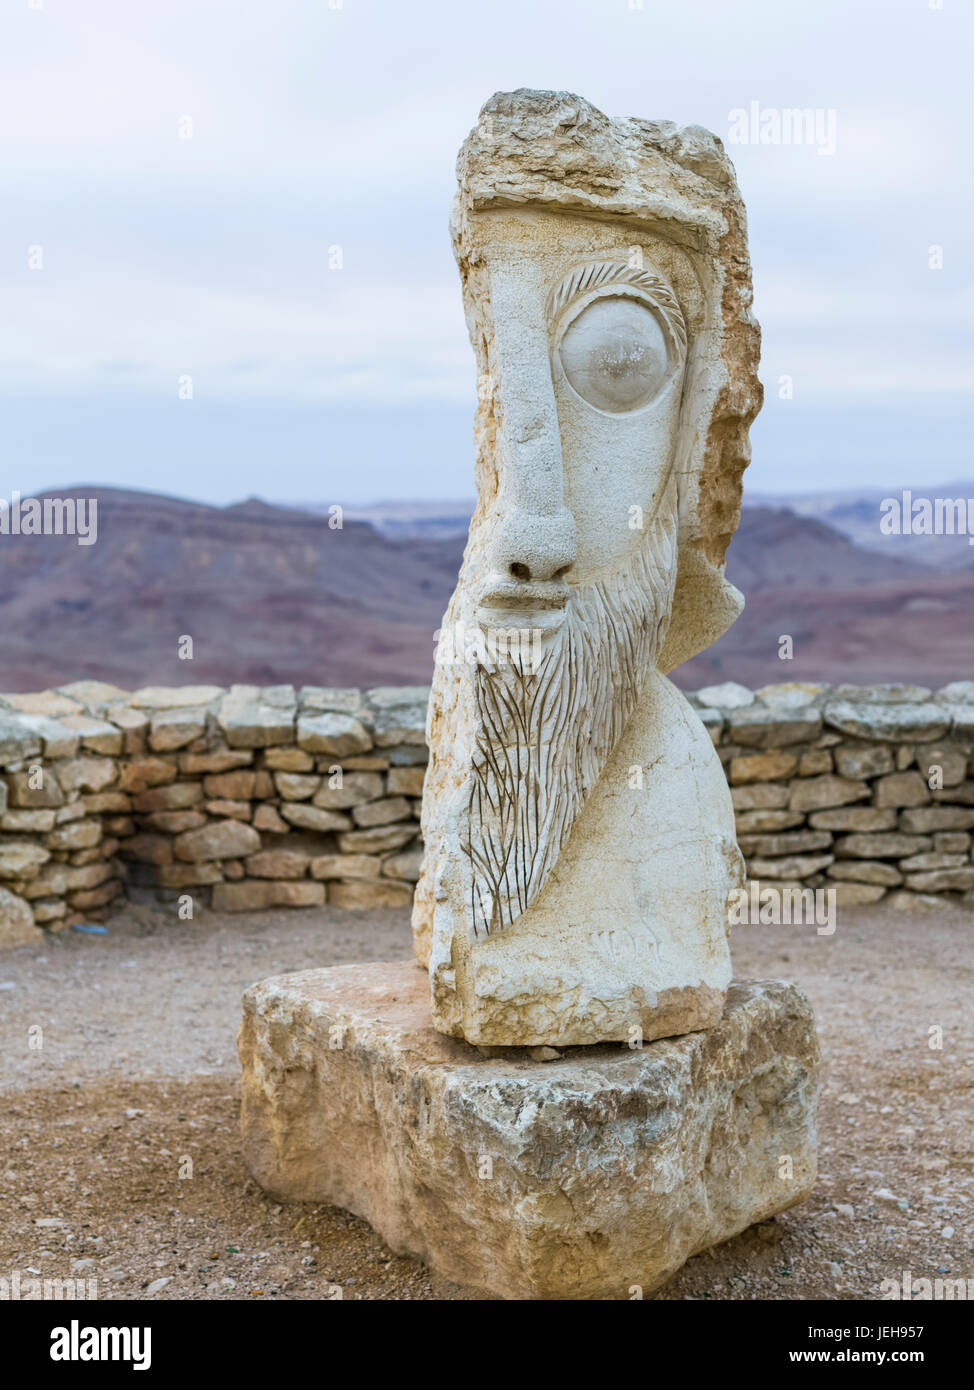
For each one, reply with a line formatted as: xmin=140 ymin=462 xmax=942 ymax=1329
xmin=0 ymin=0 xmax=974 ymax=502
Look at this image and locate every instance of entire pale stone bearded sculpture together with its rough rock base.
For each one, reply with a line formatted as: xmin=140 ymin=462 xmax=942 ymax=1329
xmin=239 ymin=92 xmax=817 ymax=1298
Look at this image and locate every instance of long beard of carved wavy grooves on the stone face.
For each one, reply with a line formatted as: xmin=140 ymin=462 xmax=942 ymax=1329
xmin=461 ymin=482 xmax=677 ymax=937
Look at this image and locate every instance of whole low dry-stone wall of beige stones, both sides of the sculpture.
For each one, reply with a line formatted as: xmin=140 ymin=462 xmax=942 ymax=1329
xmin=0 ymin=681 xmax=974 ymax=945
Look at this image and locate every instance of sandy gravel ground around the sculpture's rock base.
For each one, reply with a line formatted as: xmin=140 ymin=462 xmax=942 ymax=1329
xmin=0 ymin=905 xmax=974 ymax=1300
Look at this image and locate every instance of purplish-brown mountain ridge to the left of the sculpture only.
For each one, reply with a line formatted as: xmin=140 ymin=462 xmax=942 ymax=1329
xmin=0 ymin=484 xmax=459 ymax=691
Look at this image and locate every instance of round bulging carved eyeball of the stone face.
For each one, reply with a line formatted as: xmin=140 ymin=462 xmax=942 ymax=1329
xmin=559 ymin=295 xmax=670 ymax=414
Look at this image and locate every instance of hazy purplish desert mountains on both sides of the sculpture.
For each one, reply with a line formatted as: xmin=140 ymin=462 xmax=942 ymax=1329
xmin=0 ymin=484 xmax=974 ymax=691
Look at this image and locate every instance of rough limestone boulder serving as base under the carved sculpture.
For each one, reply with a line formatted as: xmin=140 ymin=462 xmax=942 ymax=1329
xmin=239 ymin=962 xmax=818 ymax=1298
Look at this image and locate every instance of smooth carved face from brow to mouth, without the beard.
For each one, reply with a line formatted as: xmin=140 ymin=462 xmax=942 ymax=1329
xmin=474 ymin=211 xmax=686 ymax=639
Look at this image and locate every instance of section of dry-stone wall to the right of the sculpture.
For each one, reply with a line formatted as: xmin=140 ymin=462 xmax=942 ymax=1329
xmin=691 ymin=681 xmax=974 ymax=908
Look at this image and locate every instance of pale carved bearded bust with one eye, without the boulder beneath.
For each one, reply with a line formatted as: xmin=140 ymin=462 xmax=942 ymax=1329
xmin=414 ymin=92 xmax=761 ymax=1045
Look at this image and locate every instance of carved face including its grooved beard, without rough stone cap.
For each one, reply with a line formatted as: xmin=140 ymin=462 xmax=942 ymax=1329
xmin=447 ymin=211 xmax=700 ymax=937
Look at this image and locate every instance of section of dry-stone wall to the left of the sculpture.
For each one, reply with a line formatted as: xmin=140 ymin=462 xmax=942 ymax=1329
xmin=0 ymin=681 xmax=428 ymax=945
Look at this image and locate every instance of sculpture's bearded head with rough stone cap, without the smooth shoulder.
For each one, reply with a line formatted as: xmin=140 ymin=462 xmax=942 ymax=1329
xmin=415 ymin=92 xmax=760 ymax=967
